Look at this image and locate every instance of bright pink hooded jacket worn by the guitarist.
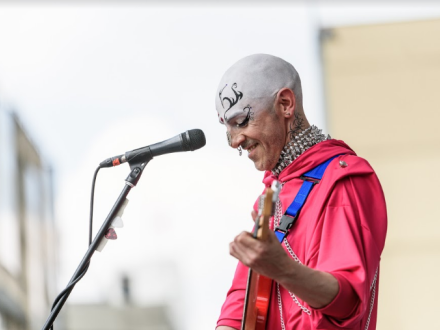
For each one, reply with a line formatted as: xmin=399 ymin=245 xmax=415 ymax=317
xmin=217 ymin=140 xmax=387 ymax=330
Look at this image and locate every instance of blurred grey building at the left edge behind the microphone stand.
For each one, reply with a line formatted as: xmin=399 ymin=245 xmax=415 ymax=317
xmin=0 ymin=103 xmax=56 ymax=330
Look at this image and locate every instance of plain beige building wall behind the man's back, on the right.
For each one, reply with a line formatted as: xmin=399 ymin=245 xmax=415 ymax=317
xmin=321 ymin=19 xmax=440 ymax=330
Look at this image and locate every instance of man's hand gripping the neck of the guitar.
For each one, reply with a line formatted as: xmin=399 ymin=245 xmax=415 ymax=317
xmin=229 ymin=231 xmax=292 ymax=280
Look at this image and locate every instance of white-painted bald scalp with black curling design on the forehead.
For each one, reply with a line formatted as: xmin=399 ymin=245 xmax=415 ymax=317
xmin=215 ymin=54 xmax=302 ymax=123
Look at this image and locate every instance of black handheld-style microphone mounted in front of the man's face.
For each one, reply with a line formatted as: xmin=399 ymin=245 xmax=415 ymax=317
xmin=99 ymin=129 xmax=206 ymax=167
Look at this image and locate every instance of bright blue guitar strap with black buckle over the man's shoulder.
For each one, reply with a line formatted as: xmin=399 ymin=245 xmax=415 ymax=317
xmin=275 ymin=155 xmax=340 ymax=243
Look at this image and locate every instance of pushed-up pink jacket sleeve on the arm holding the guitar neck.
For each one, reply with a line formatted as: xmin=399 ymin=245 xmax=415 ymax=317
xmin=310 ymin=173 xmax=387 ymax=329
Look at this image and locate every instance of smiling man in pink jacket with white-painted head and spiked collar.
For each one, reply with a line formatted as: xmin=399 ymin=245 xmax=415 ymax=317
xmin=216 ymin=54 xmax=387 ymax=330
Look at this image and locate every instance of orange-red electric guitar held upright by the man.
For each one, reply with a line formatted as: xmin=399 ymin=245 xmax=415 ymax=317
xmin=241 ymin=181 xmax=280 ymax=330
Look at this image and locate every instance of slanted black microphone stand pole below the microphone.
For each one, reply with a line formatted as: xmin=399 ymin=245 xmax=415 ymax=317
xmin=42 ymin=159 xmax=148 ymax=330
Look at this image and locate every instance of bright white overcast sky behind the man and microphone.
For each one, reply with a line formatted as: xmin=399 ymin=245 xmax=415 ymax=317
xmin=0 ymin=1 xmax=440 ymax=330
